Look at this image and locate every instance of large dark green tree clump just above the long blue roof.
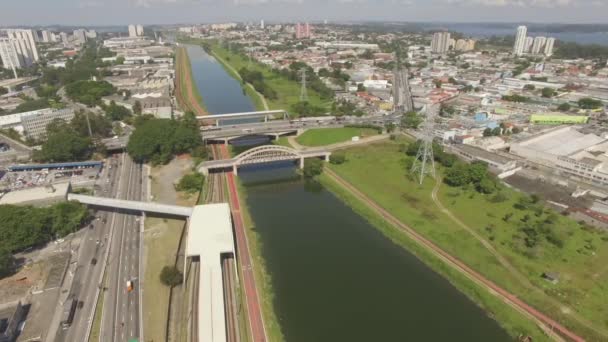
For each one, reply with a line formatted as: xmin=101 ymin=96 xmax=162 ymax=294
xmin=33 ymin=119 xmax=93 ymax=162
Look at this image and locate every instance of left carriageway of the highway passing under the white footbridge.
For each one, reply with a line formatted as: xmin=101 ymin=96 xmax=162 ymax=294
xmin=55 ymin=155 xmax=124 ymax=342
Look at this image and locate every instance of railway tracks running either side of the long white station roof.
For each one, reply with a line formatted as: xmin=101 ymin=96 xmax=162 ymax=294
xmin=191 ymin=146 xmax=240 ymax=342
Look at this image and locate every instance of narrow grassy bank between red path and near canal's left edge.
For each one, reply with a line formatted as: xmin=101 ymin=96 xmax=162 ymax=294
xmin=236 ymin=178 xmax=285 ymax=342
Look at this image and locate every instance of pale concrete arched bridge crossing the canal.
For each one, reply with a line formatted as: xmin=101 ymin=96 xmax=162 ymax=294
xmin=199 ymin=145 xmax=331 ymax=175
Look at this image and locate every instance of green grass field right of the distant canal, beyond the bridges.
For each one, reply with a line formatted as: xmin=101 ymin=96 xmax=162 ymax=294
xmin=211 ymin=43 xmax=331 ymax=111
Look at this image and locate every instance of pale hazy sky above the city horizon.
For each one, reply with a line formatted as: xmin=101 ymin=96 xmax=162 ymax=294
xmin=0 ymin=0 xmax=608 ymax=26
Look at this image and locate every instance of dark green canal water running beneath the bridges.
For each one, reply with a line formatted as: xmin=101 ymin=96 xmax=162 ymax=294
xmin=189 ymin=45 xmax=511 ymax=342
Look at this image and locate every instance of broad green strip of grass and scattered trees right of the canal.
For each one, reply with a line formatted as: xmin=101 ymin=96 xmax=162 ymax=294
xmin=329 ymin=140 xmax=608 ymax=340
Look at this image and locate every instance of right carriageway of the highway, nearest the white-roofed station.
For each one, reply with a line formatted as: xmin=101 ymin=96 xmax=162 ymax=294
xmin=101 ymin=155 xmax=143 ymax=341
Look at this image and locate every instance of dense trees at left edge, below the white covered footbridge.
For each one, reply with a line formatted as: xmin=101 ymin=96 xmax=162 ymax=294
xmin=0 ymin=202 xmax=90 ymax=276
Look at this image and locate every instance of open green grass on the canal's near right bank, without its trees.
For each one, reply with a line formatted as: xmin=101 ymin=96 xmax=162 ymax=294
xmin=329 ymin=141 xmax=608 ymax=341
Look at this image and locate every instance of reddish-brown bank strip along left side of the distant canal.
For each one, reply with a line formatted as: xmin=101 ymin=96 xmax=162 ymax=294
xmin=175 ymin=47 xmax=207 ymax=115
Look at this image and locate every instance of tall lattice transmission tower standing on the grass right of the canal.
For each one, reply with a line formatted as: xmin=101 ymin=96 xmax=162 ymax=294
xmin=412 ymin=105 xmax=439 ymax=184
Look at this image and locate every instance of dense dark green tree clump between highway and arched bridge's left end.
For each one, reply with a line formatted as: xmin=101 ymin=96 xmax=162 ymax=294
xmin=127 ymin=112 xmax=202 ymax=164
